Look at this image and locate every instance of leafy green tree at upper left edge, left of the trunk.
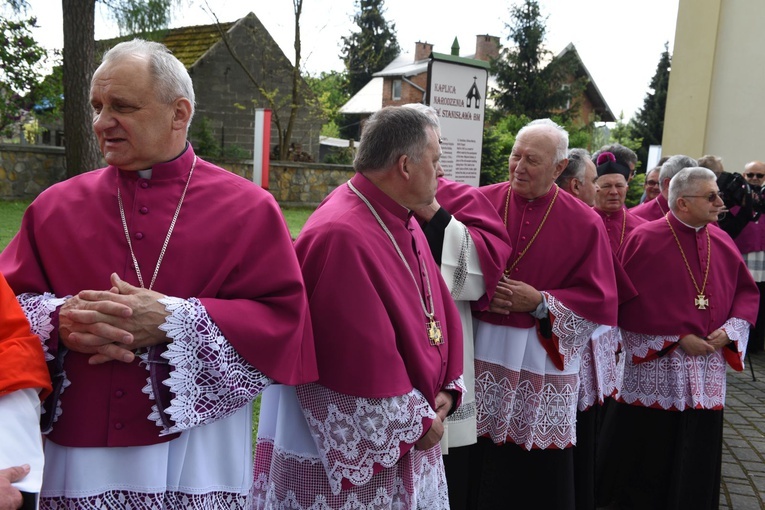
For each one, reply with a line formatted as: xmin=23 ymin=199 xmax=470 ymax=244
xmin=0 ymin=18 xmax=47 ymax=136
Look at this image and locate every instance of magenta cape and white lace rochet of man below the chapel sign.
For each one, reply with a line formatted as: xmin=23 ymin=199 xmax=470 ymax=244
xmin=476 ymin=182 xmax=617 ymax=449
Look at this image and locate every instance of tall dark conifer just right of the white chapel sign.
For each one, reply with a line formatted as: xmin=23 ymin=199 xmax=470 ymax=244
xmin=492 ymin=0 xmax=587 ymax=118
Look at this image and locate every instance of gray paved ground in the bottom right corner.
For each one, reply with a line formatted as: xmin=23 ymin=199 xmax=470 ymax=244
xmin=720 ymin=352 xmax=765 ymax=510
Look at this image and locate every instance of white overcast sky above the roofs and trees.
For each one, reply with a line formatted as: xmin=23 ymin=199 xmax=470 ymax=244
xmin=22 ymin=0 xmax=678 ymax=118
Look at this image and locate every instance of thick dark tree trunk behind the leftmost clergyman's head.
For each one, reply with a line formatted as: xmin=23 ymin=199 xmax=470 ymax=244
xmin=61 ymin=0 xmax=101 ymax=177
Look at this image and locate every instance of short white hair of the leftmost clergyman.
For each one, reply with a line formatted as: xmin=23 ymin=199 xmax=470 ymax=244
xmin=97 ymin=39 xmax=196 ymax=125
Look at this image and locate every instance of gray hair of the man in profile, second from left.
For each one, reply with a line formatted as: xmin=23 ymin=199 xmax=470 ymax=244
xmin=353 ymin=106 xmax=438 ymax=173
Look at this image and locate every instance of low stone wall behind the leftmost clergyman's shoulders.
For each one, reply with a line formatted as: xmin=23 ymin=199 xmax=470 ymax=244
xmin=0 ymin=144 xmax=353 ymax=206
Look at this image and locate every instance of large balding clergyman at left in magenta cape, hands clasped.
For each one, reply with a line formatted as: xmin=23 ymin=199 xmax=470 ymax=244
xmin=0 ymin=40 xmax=317 ymax=508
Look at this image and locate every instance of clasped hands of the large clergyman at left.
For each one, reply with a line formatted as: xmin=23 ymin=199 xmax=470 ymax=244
xmin=59 ymin=273 xmax=168 ymax=365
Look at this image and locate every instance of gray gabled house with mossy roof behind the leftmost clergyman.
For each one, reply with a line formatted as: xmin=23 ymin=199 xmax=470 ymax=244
xmin=39 ymin=13 xmax=323 ymax=160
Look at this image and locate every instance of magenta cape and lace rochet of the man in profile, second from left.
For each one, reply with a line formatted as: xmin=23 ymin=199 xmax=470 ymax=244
xmin=255 ymin=174 xmax=462 ymax=509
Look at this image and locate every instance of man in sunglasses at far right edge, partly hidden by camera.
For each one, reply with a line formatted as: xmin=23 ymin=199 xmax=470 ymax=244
xmin=733 ymin=161 xmax=765 ymax=353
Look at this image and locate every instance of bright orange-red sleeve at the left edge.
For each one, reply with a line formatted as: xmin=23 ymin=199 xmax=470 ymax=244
xmin=0 ymin=275 xmax=51 ymax=400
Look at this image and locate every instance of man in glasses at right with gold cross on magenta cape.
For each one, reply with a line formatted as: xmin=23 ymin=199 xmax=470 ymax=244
xmin=606 ymin=167 xmax=758 ymax=509
